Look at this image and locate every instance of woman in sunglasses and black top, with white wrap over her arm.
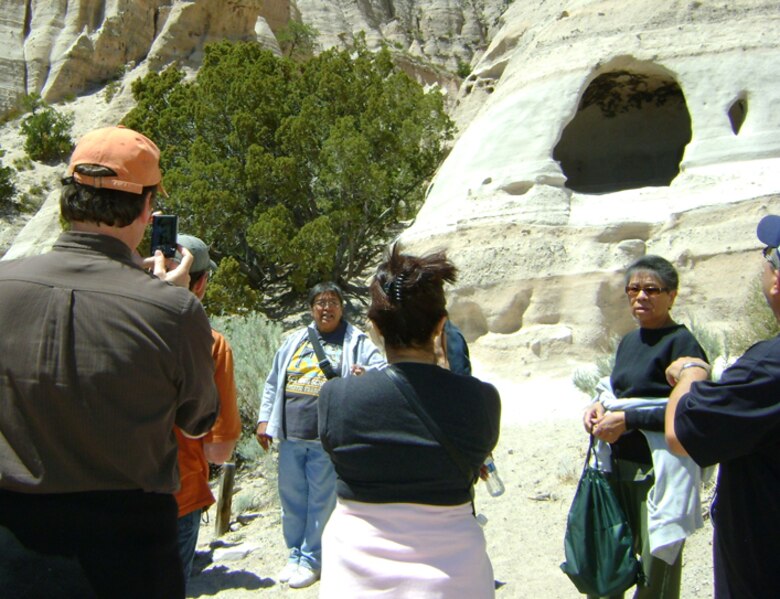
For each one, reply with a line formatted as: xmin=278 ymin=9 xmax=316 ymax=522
xmin=583 ymin=255 xmax=707 ymax=599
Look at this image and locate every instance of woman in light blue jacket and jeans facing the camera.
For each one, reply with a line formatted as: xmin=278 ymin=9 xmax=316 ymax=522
xmin=256 ymin=282 xmax=385 ymax=588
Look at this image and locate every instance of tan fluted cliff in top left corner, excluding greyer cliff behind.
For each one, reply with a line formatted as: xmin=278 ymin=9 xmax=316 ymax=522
xmin=0 ymin=0 xmax=280 ymax=111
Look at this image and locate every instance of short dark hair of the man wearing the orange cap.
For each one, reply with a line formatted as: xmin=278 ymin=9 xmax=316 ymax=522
xmin=60 ymin=164 xmax=157 ymax=227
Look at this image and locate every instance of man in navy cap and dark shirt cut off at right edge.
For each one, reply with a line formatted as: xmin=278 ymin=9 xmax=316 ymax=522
xmin=666 ymin=215 xmax=780 ymax=599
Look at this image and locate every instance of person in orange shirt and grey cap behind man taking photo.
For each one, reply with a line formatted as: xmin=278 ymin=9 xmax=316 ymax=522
xmin=175 ymin=235 xmax=241 ymax=581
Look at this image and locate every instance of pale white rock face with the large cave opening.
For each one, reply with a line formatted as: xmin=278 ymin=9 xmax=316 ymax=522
xmin=404 ymin=0 xmax=780 ymax=371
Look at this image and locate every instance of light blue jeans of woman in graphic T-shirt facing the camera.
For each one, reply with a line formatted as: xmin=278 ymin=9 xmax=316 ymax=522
xmin=279 ymin=439 xmax=336 ymax=572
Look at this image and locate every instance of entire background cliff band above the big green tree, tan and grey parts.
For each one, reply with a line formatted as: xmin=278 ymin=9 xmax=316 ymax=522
xmin=0 ymin=0 xmax=508 ymax=113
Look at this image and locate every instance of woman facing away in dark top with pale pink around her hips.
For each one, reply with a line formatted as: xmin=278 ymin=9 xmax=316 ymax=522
xmin=319 ymin=245 xmax=501 ymax=599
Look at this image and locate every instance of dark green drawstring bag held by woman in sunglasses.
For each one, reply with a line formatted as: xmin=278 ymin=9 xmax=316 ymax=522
xmin=561 ymin=435 xmax=643 ymax=597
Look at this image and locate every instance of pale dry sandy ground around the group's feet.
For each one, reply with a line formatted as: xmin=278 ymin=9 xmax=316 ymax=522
xmin=188 ymin=377 xmax=712 ymax=599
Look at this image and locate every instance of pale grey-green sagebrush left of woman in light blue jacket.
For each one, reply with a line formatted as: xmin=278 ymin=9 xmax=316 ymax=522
xmin=211 ymin=312 xmax=282 ymax=472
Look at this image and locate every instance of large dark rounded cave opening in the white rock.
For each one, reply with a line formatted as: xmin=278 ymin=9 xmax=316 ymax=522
xmin=553 ymin=70 xmax=691 ymax=194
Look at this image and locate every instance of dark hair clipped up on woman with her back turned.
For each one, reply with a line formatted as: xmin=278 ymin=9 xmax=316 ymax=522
xmin=368 ymin=244 xmax=457 ymax=348
